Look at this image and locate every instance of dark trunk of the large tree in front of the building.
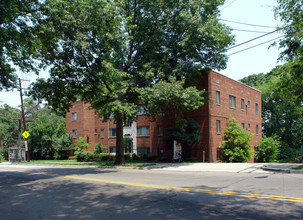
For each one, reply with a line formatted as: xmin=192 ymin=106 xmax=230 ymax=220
xmin=115 ymin=113 xmax=124 ymax=165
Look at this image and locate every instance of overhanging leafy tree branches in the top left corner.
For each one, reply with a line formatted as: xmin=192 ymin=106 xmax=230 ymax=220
xmin=0 ymin=0 xmax=43 ymax=91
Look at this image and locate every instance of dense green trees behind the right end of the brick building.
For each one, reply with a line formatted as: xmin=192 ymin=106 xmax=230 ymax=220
xmin=241 ymin=66 xmax=303 ymax=160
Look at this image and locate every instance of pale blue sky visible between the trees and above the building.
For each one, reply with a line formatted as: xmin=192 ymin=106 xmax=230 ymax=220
xmin=0 ymin=0 xmax=282 ymax=107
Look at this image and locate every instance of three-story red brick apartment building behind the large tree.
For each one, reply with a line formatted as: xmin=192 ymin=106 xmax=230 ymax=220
xmin=66 ymin=71 xmax=262 ymax=162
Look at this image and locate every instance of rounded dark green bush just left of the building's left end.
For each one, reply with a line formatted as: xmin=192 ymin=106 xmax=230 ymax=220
xmin=52 ymin=134 xmax=74 ymax=160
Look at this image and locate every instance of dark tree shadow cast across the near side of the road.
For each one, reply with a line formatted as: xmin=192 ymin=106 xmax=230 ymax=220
xmin=0 ymin=168 xmax=303 ymax=220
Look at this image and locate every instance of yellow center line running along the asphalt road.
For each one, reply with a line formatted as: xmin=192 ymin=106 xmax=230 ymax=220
xmin=0 ymin=169 xmax=303 ymax=203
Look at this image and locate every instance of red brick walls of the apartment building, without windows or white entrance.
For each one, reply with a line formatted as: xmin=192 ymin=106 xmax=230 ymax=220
xmin=66 ymin=71 xmax=262 ymax=162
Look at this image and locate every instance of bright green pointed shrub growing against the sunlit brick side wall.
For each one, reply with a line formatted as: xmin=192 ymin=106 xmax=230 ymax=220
xmin=222 ymin=117 xmax=253 ymax=162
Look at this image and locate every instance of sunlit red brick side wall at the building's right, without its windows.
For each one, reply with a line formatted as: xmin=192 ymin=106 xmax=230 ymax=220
xmin=208 ymin=72 xmax=262 ymax=162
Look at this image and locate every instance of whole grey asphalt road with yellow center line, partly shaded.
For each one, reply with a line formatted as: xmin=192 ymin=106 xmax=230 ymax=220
xmin=0 ymin=166 xmax=303 ymax=220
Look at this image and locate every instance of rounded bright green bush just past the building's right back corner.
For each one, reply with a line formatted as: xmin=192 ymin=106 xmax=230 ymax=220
xmin=255 ymin=135 xmax=281 ymax=162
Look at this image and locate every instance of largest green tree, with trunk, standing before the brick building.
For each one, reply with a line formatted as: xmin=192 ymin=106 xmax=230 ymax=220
xmin=30 ymin=0 xmax=233 ymax=164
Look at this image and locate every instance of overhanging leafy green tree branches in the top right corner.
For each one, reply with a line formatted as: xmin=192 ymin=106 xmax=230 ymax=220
xmin=275 ymin=0 xmax=303 ymax=100
